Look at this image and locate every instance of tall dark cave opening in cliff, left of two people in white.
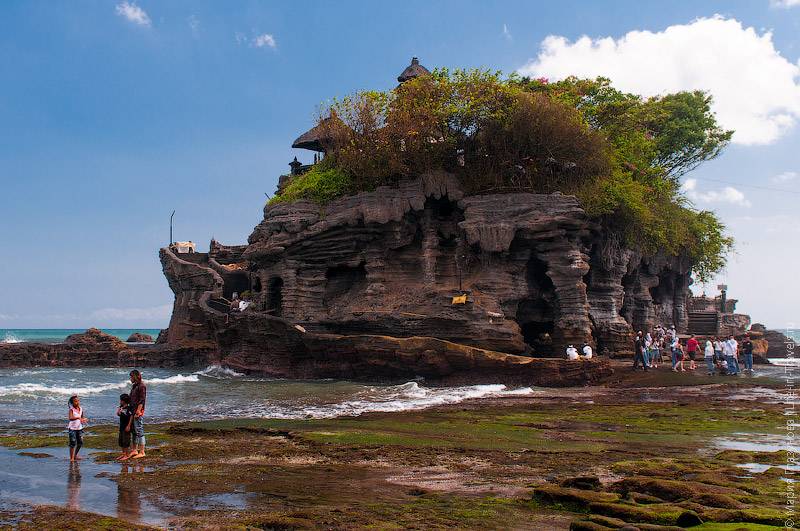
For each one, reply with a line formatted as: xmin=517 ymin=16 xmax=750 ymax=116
xmin=516 ymin=256 xmax=556 ymax=357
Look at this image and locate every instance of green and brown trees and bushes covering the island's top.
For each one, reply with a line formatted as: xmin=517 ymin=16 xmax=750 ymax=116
xmin=271 ymin=69 xmax=733 ymax=281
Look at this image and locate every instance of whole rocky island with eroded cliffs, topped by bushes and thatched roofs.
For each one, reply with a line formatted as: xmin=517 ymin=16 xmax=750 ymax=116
xmin=155 ymin=60 xmax=744 ymax=385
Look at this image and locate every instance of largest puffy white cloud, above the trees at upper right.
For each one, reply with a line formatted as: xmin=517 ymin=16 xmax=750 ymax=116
xmin=519 ymin=16 xmax=800 ymax=145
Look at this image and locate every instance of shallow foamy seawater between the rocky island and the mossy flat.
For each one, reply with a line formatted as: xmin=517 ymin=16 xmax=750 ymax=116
xmin=0 ymin=367 xmax=544 ymax=428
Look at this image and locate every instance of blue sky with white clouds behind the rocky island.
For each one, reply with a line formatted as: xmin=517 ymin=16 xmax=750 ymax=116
xmin=0 ymin=0 xmax=800 ymax=328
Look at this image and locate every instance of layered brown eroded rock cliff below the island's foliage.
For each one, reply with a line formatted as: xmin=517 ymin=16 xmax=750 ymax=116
xmin=161 ymin=174 xmax=690 ymax=381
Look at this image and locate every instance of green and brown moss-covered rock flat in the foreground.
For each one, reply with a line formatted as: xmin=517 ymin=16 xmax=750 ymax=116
xmin=0 ymin=372 xmax=787 ymax=531
